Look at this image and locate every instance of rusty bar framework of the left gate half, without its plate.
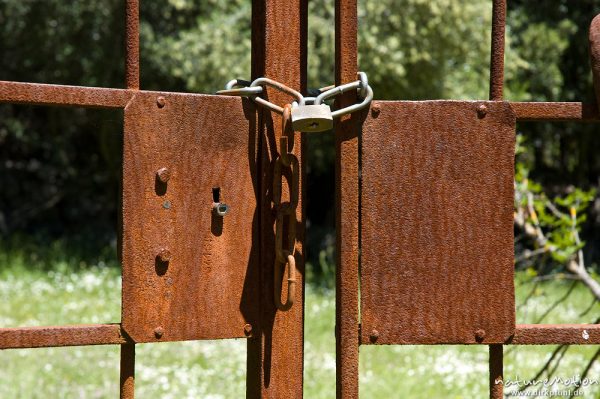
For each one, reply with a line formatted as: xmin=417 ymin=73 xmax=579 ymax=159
xmin=0 ymin=0 xmax=308 ymax=399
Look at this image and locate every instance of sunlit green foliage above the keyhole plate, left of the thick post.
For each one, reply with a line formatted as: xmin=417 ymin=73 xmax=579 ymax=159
xmin=141 ymin=0 xmax=251 ymax=93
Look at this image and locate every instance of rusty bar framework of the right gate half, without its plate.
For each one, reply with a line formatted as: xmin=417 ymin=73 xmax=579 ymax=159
xmin=335 ymin=0 xmax=600 ymax=399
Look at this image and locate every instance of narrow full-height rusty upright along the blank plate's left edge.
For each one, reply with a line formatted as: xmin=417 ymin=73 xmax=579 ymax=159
xmin=335 ymin=0 xmax=360 ymax=399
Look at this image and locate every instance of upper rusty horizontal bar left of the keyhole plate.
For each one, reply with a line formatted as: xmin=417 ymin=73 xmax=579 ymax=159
xmin=0 ymin=81 xmax=134 ymax=108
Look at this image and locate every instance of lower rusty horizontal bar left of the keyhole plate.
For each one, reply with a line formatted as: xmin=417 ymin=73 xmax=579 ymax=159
xmin=0 ymin=324 xmax=130 ymax=349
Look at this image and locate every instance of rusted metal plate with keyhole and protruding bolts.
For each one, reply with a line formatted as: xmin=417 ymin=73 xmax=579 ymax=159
xmin=122 ymin=92 xmax=258 ymax=342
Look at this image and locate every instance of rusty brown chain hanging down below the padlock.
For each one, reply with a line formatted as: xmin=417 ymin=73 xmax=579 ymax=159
xmin=273 ymin=104 xmax=300 ymax=311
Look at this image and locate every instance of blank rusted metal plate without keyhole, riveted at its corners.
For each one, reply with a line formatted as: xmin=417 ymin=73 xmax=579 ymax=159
xmin=361 ymin=101 xmax=516 ymax=344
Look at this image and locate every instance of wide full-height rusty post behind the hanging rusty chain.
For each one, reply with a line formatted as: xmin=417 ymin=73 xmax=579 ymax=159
xmin=246 ymin=0 xmax=308 ymax=398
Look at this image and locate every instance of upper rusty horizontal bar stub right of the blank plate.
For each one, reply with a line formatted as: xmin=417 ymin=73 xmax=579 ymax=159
xmin=510 ymin=102 xmax=600 ymax=122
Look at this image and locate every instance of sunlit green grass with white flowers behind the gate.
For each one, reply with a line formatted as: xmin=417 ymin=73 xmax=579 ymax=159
xmin=0 ymin=253 xmax=600 ymax=399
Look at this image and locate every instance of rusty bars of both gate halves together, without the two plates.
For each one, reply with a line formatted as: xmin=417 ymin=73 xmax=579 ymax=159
xmin=0 ymin=0 xmax=600 ymax=399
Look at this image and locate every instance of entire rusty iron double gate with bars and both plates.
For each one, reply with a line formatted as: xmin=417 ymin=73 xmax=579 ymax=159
xmin=0 ymin=0 xmax=600 ymax=399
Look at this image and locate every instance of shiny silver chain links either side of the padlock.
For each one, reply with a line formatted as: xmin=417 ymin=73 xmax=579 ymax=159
xmin=217 ymin=72 xmax=373 ymax=118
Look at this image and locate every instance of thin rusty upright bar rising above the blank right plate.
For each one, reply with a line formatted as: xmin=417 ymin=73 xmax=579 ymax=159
xmin=490 ymin=0 xmax=506 ymax=101
